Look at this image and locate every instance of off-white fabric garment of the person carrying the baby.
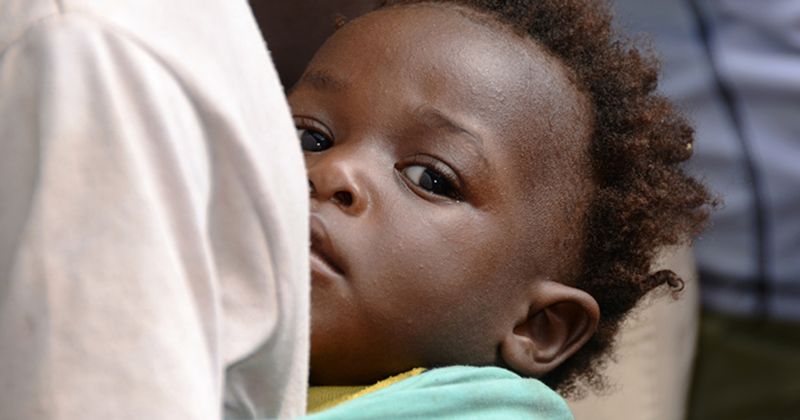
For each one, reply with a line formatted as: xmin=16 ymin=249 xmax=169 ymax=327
xmin=0 ymin=0 xmax=309 ymax=420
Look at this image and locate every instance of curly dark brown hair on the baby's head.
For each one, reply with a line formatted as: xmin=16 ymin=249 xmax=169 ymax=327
xmin=380 ymin=0 xmax=714 ymax=395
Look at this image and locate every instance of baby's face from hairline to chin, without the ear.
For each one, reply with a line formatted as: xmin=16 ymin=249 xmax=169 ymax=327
xmin=289 ymin=6 xmax=590 ymax=384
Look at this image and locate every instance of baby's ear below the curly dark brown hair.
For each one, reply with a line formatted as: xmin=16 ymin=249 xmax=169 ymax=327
xmin=500 ymin=280 xmax=600 ymax=378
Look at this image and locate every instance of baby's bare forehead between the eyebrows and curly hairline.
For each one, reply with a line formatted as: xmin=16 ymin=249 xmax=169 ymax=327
xmin=310 ymin=4 xmax=591 ymax=147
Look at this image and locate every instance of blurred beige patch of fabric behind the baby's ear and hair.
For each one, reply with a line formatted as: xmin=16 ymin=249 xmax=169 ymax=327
xmin=569 ymin=248 xmax=699 ymax=420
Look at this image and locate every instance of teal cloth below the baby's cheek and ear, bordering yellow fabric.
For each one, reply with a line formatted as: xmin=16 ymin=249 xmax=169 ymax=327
xmin=304 ymin=366 xmax=573 ymax=420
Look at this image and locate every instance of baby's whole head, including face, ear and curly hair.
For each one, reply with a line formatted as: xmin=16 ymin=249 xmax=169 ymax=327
xmin=289 ymin=0 xmax=708 ymax=391
